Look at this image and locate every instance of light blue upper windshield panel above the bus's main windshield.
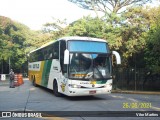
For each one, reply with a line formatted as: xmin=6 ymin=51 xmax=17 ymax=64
xmin=68 ymin=40 xmax=108 ymax=53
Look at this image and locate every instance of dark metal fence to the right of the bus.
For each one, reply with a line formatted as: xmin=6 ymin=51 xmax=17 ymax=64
xmin=113 ymin=68 xmax=160 ymax=91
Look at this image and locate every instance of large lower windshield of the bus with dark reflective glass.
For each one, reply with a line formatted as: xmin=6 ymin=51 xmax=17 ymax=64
xmin=69 ymin=53 xmax=111 ymax=80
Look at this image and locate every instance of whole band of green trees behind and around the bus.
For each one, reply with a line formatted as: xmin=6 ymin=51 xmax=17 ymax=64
xmin=0 ymin=0 xmax=160 ymax=72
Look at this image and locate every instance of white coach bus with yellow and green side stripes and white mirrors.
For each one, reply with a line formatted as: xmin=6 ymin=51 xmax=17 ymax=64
xmin=28 ymin=36 xmax=121 ymax=97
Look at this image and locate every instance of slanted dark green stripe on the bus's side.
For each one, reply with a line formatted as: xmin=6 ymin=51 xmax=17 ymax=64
xmin=41 ymin=60 xmax=52 ymax=87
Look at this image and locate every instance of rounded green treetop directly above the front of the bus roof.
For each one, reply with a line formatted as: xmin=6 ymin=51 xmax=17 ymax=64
xmin=67 ymin=16 xmax=105 ymax=38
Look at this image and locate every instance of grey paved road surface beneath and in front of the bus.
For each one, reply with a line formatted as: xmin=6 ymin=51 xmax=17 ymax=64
xmin=0 ymin=79 xmax=160 ymax=120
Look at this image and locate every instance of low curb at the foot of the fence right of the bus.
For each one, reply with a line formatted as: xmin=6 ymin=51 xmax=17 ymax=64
xmin=112 ymin=90 xmax=160 ymax=95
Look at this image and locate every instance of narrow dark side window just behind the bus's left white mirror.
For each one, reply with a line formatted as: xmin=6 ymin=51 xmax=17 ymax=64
xmin=60 ymin=40 xmax=67 ymax=74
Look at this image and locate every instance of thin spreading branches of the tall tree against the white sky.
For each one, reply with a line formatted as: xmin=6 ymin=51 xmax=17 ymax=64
xmin=69 ymin=0 xmax=151 ymax=16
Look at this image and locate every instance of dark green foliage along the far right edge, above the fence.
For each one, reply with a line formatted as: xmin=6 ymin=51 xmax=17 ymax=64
xmin=145 ymin=7 xmax=160 ymax=73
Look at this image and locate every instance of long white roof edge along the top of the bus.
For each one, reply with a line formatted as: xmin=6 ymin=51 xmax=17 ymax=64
xmin=29 ymin=36 xmax=107 ymax=54
